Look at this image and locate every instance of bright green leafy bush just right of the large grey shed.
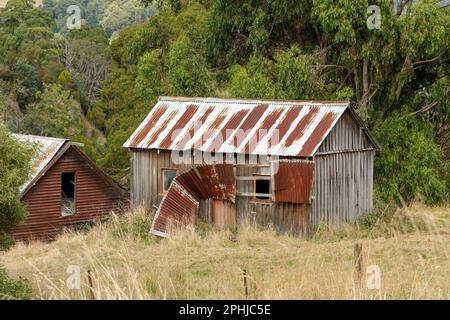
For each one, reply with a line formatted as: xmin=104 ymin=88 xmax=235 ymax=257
xmin=375 ymin=113 xmax=450 ymax=205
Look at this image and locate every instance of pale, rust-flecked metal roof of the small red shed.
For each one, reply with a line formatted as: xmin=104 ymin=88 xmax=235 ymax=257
xmin=13 ymin=134 xmax=69 ymax=193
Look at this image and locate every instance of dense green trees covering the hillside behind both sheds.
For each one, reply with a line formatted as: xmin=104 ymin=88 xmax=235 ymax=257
xmin=0 ymin=0 xmax=450 ymax=203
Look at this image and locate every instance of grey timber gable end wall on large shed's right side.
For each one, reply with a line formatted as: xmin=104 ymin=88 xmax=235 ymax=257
xmin=309 ymin=111 xmax=375 ymax=227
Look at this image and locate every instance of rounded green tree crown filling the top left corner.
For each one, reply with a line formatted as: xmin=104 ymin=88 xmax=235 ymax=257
xmin=0 ymin=0 xmax=64 ymax=111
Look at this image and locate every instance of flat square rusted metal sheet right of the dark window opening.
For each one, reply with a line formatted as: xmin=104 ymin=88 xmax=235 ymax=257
xmin=274 ymin=160 xmax=314 ymax=204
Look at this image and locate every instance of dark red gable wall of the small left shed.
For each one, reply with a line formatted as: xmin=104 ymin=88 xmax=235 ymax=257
xmin=12 ymin=147 xmax=123 ymax=240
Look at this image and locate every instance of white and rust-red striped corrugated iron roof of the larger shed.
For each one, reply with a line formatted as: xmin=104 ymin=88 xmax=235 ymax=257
xmin=124 ymin=97 xmax=349 ymax=157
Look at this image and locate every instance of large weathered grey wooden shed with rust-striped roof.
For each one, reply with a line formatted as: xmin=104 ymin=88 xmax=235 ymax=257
xmin=124 ymin=97 xmax=378 ymax=236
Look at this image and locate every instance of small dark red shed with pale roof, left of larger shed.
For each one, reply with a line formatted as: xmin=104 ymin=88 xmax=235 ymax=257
xmin=11 ymin=134 xmax=126 ymax=240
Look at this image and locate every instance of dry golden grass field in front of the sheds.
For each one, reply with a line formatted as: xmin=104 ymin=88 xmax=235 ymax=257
xmin=0 ymin=205 xmax=450 ymax=299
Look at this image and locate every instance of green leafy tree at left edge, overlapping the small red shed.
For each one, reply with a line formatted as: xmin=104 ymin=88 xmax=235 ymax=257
xmin=0 ymin=123 xmax=33 ymax=247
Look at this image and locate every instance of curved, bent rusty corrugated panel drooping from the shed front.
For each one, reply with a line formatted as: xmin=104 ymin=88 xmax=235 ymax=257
xmin=151 ymin=163 xmax=236 ymax=237
